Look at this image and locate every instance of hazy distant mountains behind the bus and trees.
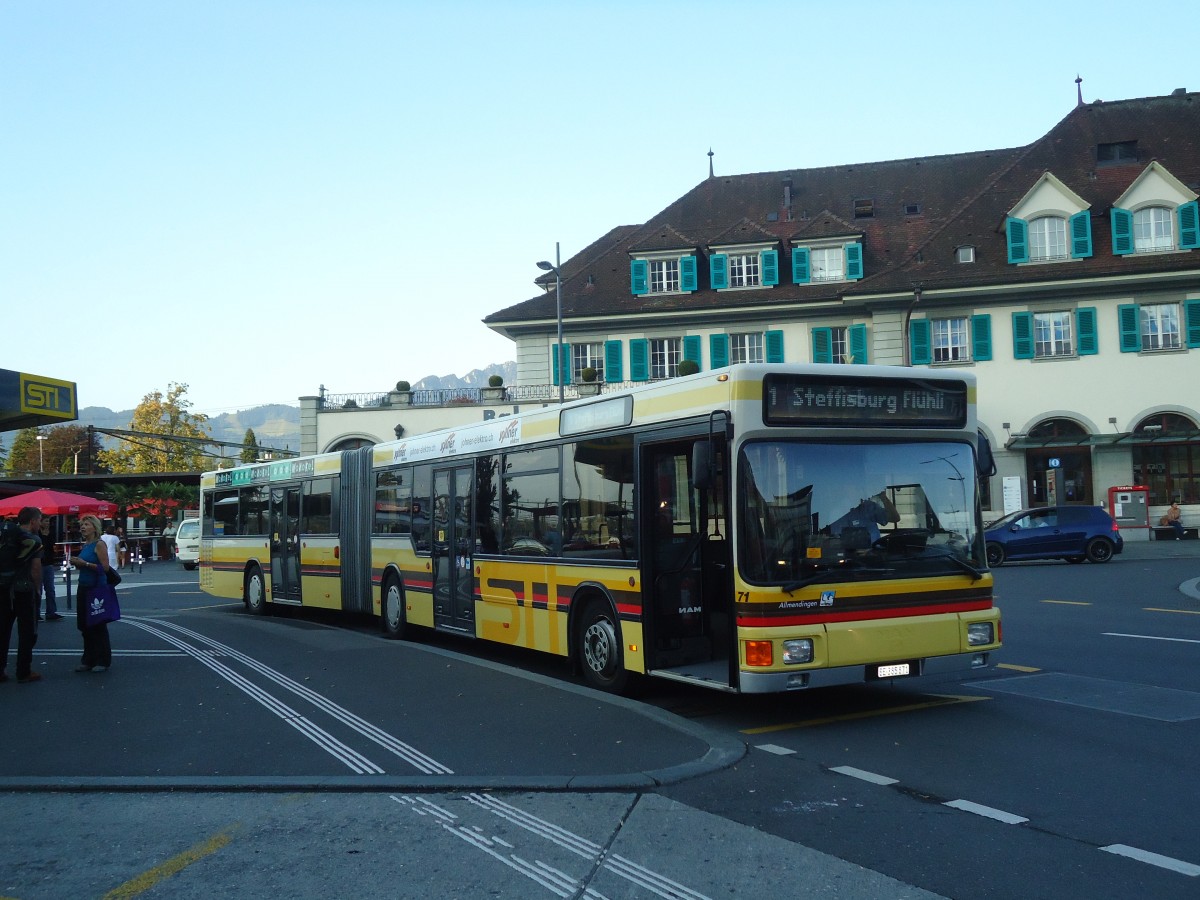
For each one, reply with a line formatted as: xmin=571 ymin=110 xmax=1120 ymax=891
xmin=72 ymin=362 xmax=517 ymax=454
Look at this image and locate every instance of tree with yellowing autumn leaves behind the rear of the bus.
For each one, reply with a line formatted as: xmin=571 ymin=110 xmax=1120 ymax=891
xmin=100 ymin=382 xmax=211 ymax=473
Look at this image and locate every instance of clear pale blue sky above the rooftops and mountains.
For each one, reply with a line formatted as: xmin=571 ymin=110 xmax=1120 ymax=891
xmin=0 ymin=0 xmax=1200 ymax=415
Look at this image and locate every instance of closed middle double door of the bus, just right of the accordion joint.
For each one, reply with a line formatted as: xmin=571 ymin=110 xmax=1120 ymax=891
xmin=433 ymin=466 xmax=475 ymax=634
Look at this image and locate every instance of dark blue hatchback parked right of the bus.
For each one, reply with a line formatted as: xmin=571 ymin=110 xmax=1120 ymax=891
xmin=984 ymin=506 xmax=1124 ymax=568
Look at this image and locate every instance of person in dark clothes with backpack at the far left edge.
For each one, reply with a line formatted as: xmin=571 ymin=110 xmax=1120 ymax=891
xmin=0 ymin=506 xmax=42 ymax=684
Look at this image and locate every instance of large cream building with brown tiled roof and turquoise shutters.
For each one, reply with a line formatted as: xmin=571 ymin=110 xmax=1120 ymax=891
xmin=485 ymin=90 xmax=1200 ymax=528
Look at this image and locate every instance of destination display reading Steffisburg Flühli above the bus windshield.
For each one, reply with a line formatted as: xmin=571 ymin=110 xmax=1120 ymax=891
xmin=763 ymin=373 xmax=967 ymax=428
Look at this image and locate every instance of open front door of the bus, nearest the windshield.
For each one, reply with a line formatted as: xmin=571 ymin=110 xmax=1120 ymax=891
xmin=641 ymin=439 xmax=732 ymax=686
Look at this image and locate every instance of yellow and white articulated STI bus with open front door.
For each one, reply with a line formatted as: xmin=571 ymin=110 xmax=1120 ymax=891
xmin=199 ymin=365 xmax=1001 ymax=692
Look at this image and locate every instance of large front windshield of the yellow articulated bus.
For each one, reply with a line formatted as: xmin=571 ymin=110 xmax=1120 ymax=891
xmin=738 ymin=440 xmax=984 ymax=592
